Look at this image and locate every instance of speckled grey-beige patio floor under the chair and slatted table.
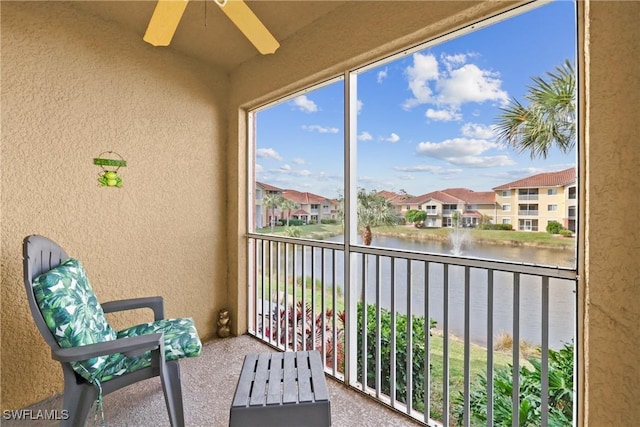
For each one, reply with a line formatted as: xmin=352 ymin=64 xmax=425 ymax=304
xmin=7 ymin=335 xmax=423 ymax=427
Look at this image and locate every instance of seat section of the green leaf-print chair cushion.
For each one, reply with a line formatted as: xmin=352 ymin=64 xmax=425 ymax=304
xmin=99 ymin=318 xmax=202 ymax=382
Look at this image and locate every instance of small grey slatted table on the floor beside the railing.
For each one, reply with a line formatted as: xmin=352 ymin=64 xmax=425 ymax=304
xmin=229 ymin=351 xmax=331 ymax=427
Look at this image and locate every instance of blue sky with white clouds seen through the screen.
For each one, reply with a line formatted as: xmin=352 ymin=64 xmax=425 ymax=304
xmin=256 ymin=1 xmax=576 ymax=201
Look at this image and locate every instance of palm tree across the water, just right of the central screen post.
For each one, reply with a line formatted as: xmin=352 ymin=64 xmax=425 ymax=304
xmin=357 ymin=188 xmax=398 ymax=246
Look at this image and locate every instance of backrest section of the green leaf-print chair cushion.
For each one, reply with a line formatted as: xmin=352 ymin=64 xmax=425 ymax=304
xmin=33 ymin=258 xmax=117 ymax=382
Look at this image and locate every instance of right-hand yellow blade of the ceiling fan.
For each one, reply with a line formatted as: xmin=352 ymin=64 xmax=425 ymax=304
xmin=216 ymin=0 xmax=280 ymax=55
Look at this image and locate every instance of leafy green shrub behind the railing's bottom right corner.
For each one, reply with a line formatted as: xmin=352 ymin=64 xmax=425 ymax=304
xmin=453 ymin=344 xmax=573 ymax=427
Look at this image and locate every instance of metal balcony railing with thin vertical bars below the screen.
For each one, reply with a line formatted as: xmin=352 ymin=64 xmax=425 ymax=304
xmin=248 ymin=234 xmax=577 ymax=426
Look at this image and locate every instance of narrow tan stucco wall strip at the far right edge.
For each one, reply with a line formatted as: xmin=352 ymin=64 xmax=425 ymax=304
xmin=584 ymin=1 xmax=640 ymax=427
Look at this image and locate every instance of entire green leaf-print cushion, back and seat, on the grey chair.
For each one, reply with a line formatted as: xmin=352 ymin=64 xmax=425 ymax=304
xmin=33 ymin=258 xmax=202 ymax=383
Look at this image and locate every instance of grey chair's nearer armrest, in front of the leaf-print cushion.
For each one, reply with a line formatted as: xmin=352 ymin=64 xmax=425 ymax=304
xmin=51 ymin=333 xmax=164 ymax=362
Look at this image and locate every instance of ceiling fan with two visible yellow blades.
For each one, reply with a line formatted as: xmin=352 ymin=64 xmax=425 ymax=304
xmin=143 ymin=0 xmax=280 ymax=55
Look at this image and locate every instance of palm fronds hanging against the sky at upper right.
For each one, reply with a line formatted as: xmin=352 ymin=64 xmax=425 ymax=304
xmin=496 ymin=60 xmax=576 ymax=159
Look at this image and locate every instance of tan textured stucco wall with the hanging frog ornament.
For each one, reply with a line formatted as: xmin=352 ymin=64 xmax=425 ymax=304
xmin=1 ymin=1 xmax=228 ymax=409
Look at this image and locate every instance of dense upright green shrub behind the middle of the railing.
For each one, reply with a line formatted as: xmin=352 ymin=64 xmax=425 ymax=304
xmin=358 ymin=303 xmax=436 ymax=411
